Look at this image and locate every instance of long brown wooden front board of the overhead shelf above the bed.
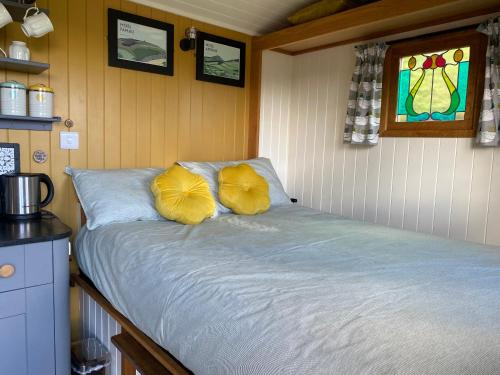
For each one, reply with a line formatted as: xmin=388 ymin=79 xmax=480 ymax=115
xmin=252 ymin=0 xmax=470 ymax=49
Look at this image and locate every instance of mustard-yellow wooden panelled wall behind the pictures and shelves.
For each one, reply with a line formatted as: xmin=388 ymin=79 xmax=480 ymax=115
xmin=0 ymin=0 xmax=251 ymax=234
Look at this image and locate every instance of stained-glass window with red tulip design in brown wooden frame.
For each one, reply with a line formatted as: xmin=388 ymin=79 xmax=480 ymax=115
xmin=380 ymin=28 xmax=487 ymax=138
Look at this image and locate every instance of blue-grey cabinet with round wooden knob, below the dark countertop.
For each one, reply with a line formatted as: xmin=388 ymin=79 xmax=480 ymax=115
xmin=0 ymin=238 xmax=70 ymax=375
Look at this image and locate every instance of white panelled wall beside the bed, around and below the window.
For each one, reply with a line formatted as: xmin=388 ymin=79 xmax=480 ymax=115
xmin=259 ymin=45 xmax=500 ymax=245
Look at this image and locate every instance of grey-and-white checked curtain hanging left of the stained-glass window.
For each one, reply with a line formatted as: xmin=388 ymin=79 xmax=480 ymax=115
xmin=344 ymin=43 xmax=387 ymax=145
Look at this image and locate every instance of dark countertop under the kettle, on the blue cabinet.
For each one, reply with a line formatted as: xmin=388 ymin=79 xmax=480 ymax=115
xmin=0 ymin=212 xmax=71 ymax=247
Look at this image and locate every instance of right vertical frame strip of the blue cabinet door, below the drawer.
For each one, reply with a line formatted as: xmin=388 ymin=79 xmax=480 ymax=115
xmin=26 ymin=284 xmax=55 ymax=375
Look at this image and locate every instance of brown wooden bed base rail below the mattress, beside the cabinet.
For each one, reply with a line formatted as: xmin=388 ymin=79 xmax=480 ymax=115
xmin=71 ymin=273 xmax=192 ymax=375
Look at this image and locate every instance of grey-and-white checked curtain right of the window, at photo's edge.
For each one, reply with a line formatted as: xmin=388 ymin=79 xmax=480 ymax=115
xmin=476 ymin=17 xmax=500 ymax=146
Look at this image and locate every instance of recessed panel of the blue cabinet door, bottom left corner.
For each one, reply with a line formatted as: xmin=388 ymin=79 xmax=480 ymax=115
xmin=0 ymin=314 xmax=27 ymax=375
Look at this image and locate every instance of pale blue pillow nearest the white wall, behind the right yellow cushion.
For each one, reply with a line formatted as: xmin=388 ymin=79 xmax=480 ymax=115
xmin=177 ymin=158 xmax=291 ymax=213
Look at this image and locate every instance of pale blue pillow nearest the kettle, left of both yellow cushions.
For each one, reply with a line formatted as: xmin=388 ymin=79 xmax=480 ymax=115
xmin=65 ymin=167 xmax=165 ymax=230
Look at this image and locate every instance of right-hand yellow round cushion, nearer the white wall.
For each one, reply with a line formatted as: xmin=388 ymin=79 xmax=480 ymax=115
xmin=219 ymin=164 xmax=271 ymax=215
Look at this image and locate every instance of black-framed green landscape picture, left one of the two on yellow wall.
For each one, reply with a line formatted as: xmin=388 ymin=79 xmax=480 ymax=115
xmin=108 ymin=9 xmax=174 ymax=76
